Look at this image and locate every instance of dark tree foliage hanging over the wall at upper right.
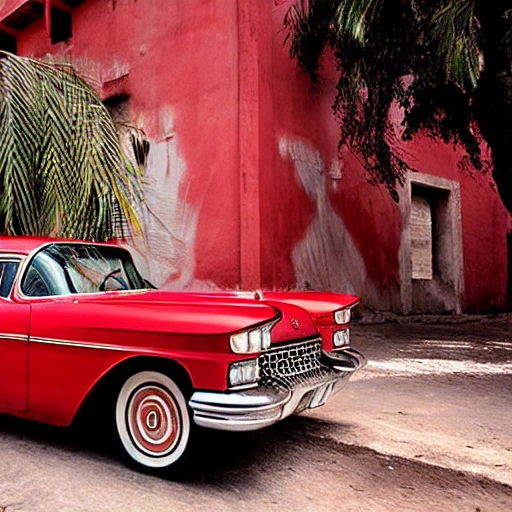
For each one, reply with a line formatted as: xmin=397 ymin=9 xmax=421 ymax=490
xmin=284 ymin=0 xmax=512 ymax=213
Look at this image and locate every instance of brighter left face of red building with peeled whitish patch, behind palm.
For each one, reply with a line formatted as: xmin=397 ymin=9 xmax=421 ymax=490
xmin=13 ymin=0 xmax=240 ymax=287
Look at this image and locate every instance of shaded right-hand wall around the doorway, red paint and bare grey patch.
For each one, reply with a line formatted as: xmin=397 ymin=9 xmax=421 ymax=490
xmin=261 ymin=0 xmax=509 ymax=312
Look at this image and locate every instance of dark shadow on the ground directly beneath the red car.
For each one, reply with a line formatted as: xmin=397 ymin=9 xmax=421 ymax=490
xmin=0 ymin=415 xmax=353 ymax=486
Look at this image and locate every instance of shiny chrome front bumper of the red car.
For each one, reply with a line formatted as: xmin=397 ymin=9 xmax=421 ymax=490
xmin=189 ymin=348 xmax=366 ymax=431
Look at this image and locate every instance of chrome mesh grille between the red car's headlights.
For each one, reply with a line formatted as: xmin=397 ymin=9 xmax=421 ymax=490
xmin=259 ymin=338 xmax=331 ymax=387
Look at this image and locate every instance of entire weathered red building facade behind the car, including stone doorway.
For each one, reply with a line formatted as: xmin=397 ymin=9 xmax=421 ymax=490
xmin=0 ymin=0 xmax=509 ymax=313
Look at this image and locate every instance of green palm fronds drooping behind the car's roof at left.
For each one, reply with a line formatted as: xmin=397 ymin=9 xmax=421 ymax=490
xmin=0 ymin=52 xmax=142 ymax=240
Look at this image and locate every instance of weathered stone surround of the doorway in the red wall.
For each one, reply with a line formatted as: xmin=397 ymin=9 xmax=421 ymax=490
xmin=399 ymin=171 xmax=464 ymax=314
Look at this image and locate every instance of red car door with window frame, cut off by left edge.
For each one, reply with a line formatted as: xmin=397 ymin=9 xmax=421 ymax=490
xmin=0 ymin=257 xmax=30 ymax=411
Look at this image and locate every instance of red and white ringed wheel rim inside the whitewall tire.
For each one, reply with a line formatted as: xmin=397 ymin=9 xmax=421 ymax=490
xmin=127 ymin=385 xmax=181 ymax=456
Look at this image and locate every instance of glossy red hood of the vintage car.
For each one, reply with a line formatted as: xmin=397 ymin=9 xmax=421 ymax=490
xmin=32 ymin=290 xmax=318 ymax=343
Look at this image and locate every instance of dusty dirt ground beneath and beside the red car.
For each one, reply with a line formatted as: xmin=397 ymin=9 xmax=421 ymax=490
xmin=0 ymin=316 xmax=512 ymax=512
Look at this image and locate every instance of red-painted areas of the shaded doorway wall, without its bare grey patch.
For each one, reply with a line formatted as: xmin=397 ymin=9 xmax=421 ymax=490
xmin=261 ymin=1 xmax=509 ymax=311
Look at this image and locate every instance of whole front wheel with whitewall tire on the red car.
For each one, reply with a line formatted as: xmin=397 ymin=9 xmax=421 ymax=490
xmin=115 ymin=371 xmax=191 ymax=472
